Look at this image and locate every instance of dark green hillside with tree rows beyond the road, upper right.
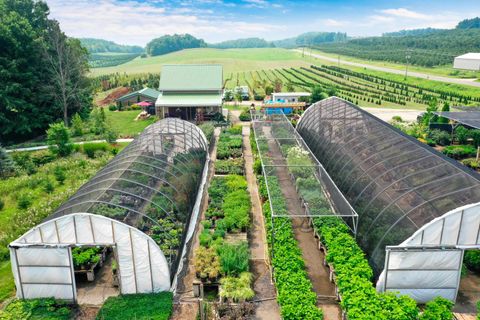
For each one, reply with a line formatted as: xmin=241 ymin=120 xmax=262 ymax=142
xmin=315 ymin=19 xmax=480 ymax=67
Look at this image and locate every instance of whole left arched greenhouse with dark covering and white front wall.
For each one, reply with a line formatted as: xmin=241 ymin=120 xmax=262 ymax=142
xmin=10 ymin=118 xmax=209 ymax=301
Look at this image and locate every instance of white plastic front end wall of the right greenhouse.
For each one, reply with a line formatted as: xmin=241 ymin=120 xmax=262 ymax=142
xmin=377 ymin=203 xmax=480 ymax=303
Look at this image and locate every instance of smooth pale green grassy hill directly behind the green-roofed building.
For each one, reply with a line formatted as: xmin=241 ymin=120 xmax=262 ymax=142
xmin=91 ymin=48 xmax=308 ymax=78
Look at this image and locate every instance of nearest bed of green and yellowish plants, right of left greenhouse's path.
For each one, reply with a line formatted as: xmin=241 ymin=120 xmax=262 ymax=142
xmin=194 ymin=175 xmax=254 ymax=302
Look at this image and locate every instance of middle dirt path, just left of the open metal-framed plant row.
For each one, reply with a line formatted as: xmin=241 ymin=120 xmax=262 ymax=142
xmin=242 ymin=122 xmax=281 ymax=320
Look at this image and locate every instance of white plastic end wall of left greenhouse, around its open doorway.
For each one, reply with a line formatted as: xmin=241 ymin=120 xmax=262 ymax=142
xmin=10 ymin=213 xmax=170 ymax=300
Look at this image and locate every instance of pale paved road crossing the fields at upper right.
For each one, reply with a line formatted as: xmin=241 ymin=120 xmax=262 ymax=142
xmin=294 ymin=49 xmax=480 ymax=88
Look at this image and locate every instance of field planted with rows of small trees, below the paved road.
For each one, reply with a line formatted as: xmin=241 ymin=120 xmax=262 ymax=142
xmin=225 ymin=65 xmax=480 ymax=110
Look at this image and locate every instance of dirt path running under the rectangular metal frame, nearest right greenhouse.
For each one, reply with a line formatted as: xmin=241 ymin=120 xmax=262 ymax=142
xmin=265 ymin=126 xmax=342 ymax=320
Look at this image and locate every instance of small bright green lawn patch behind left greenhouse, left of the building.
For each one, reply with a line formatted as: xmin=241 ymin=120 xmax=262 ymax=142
xmin=105 ymin=108 xmax=155 ymax=138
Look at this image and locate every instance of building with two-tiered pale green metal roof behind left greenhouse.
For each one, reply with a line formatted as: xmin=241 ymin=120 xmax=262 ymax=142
xmin=155 ymin=64 xmax=223 ymax=121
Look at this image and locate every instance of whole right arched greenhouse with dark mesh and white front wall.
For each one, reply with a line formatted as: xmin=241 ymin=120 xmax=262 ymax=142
xmin=297 ymin=97 xmax=480 ymax=302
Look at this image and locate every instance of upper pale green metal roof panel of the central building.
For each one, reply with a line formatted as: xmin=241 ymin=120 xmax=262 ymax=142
xmin=160 ymin=64 xmax=223 ymax=91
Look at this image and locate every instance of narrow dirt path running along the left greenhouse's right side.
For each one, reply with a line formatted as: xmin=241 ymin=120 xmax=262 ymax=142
xmin=170 ymin=128 xmax=220 ymax=320
